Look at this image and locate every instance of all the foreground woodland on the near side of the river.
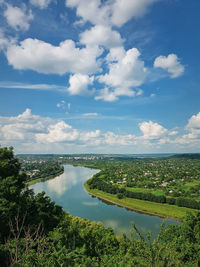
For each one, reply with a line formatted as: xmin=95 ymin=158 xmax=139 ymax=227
xmin=0 ymin=148 xmax=200 ymax=267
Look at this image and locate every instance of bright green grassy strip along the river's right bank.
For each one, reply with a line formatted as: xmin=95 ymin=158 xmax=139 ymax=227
xmin=84 ymin=183 xmax=197 ymax=222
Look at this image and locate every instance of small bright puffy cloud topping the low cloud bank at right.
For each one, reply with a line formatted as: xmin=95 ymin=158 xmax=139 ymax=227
xmin=139 ymin=121 xmax=168 ymax=140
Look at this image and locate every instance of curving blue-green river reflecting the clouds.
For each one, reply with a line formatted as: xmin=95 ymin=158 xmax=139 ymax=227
xmin=30 ymin=165 xmax=178 ymax=237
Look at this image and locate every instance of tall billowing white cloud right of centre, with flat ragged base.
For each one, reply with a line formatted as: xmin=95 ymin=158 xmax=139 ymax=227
xmin=96 ymin=47 xmax=147 ymax=101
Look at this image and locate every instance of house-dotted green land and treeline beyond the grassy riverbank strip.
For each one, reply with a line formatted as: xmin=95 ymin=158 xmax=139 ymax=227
xmin=85 ymin=157 xmax=200 ymax=210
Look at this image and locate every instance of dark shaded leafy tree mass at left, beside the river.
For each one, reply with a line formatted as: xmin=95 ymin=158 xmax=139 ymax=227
xmin=0 ymin=147 xmax=64 ymax=251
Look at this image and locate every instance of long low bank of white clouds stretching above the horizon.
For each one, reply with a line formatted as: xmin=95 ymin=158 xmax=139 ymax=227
xmin=0 ymin=109 xmax=200 ymax=153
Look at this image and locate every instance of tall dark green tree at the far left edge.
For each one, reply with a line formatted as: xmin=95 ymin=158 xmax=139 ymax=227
xmin=0 ymin=147 xmax=27 ymax=241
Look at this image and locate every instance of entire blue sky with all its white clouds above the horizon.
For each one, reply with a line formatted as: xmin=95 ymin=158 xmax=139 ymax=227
xmin=0 ymin=0 xmax=200 ymax=154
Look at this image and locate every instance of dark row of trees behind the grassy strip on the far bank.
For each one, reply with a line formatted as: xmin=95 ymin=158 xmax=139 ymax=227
xmin=87 ymin=172 xmax=200 ymax=210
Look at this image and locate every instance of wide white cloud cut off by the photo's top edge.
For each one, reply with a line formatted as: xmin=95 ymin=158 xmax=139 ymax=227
xmin=66 ymin=0 xmax=158 ymax=27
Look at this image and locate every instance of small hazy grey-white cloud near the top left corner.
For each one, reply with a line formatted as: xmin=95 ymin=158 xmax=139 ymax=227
xmin=4 ymin=4 xmax=33 ymax=31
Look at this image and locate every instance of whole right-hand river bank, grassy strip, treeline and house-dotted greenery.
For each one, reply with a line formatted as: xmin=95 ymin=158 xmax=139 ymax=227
xmin=83 ymin=155 xmax=200 ymax=220
